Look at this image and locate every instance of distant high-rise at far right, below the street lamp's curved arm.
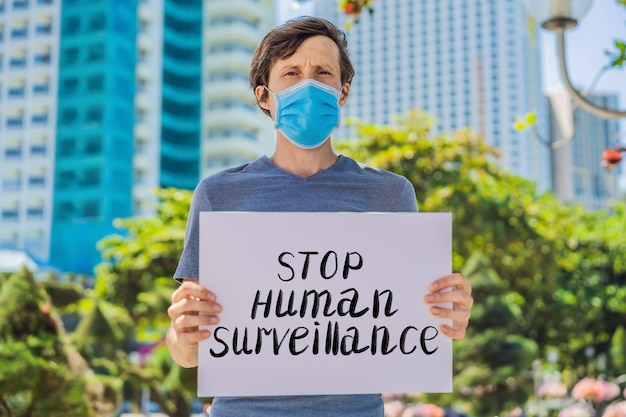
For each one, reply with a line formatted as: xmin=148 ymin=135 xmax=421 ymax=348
xmin=548 ymin=87 xmax=619 ymax=210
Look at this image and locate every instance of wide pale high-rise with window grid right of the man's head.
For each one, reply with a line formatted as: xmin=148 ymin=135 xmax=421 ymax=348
xmin=288 ymin=0 xmax=551 ymax=190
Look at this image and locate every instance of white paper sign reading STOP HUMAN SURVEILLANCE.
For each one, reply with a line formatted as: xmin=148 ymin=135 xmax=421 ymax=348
xmin=198 ymin=212 xmax=452 ymax=397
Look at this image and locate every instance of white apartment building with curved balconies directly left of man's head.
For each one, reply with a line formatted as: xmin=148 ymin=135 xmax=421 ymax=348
xmin=201 ymin=0 xmax=276 ymax=176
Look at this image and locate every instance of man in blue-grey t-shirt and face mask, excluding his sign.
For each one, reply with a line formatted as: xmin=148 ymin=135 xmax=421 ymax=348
xmin=167 ymin=17 xmax=473 ymax=417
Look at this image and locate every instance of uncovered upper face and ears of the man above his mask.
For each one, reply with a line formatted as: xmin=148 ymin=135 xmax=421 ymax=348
xmin=255 ymin=36 xmax=350 ymax=117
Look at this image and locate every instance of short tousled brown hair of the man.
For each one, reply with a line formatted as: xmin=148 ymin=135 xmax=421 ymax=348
xmin=249 ymin=17 xmax=354 ymax=116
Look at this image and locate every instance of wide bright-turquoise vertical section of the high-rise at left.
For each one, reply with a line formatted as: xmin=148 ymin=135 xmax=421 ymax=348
xmin=50 ymin=0 xmax=137 ymax=273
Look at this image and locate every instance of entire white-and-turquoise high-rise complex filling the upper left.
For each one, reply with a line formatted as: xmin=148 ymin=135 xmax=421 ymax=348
xmin=0 ymin=0 xmax=276 ymax=274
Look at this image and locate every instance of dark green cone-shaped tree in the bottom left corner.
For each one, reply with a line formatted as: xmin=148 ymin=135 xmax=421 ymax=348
xmin=0 ymin=270 xmax=115 ymax=417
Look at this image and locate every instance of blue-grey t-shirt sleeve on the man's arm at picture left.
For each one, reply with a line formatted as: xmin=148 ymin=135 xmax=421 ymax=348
xmin=174 ymin=182 xmax=212 ymax=282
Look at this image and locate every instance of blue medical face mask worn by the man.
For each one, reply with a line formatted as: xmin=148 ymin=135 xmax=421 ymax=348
xmin=264 ymin=78 xmax=341 ymax=149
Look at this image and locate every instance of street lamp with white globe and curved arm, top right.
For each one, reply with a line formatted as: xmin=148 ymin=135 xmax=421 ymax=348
xmin=524 ymin=0 xmax=626 ymax=119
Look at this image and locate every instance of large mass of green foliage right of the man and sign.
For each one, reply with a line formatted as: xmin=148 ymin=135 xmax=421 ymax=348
xmin=337 ymin=112 xmax=626 ymax=415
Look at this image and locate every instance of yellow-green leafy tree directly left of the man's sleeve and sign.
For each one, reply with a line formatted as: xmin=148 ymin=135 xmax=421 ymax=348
xmin=73 ymin=189 xmax=196 ymax=417
